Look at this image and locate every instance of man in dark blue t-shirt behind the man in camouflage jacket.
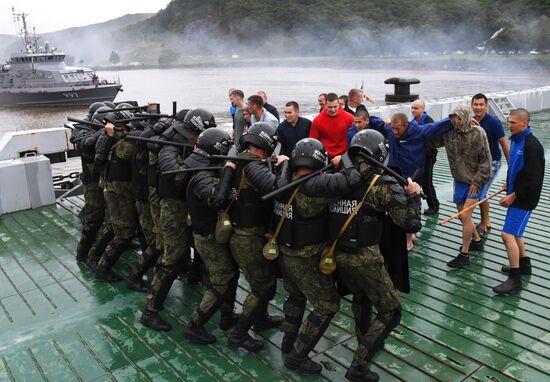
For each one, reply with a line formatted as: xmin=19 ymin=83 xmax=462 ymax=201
xmin=472 ymin=93 xmax=510 ymax=236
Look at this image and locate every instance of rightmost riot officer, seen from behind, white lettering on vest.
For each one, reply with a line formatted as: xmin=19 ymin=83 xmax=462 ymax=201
xmin=329 ymin=129 xmax=421 ymax=381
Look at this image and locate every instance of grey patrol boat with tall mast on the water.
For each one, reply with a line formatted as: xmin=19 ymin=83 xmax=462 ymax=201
xmin=0 ymin=8 xmax=122 ymax=106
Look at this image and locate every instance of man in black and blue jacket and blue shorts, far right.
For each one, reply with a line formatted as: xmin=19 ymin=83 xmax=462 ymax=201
xmin=493 ymin=108 xmax=545 ymax=294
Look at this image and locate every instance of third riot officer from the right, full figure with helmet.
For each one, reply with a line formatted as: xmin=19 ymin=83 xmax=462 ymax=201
xmin=228 ymin=122 xmax=289 ymax=352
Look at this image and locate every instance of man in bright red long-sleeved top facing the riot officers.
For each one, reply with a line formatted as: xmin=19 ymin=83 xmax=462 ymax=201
xmin=309 ymin=93 xmax=354 ymax=158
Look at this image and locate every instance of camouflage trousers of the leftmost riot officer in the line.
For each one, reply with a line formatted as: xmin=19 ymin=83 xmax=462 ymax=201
xmin=76 ymin=182 xmax=105 ymax=259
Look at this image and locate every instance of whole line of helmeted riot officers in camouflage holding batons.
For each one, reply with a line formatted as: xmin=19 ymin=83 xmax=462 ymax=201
xmin=67 ymin=96 xmax=544 ymax=381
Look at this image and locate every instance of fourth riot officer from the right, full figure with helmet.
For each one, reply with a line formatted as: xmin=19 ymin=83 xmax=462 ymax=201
xmin=183 ymin=129 xmax=239 ymax=344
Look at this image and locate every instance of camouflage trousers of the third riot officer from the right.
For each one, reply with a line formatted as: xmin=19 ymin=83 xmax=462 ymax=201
xmin=230 ymin=233 xmax=277 ymax=320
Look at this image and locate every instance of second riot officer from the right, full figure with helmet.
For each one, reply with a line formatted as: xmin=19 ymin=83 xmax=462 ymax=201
xmin=274 ymin=138 xmax=360 ymax=374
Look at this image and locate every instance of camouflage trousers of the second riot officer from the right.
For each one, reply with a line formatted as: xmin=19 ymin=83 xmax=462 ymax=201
xmin=279 ymin=246 xmax=340 ymax=355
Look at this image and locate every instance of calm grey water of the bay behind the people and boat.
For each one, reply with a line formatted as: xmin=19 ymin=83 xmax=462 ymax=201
xmin=0 ymin=67 xmax=550 ymax=131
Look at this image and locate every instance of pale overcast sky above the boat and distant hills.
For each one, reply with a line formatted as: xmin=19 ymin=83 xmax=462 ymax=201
xmin=0 ymin=0 xmax=170 ymax=35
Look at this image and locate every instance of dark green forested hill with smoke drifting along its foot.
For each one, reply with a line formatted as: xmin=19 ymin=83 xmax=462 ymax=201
xmin=124 ymin=0 xmax=550 ymax=55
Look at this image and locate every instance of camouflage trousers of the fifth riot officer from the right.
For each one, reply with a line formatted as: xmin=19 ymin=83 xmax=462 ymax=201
xmin=145 ymin=198 xmax=191 ymax=312
